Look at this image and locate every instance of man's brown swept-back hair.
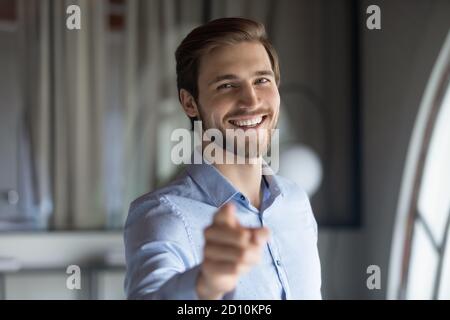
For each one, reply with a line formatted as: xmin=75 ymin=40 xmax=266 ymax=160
xmin=175 ymin=18 xmax=280 ymax=126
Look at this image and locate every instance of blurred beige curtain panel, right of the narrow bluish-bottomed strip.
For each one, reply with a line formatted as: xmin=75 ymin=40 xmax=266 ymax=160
xmin=49 ymin=0 xmax=107 ymax=229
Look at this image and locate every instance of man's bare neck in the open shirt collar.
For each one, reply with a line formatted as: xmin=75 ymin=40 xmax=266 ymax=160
xmin=214 ymin=159 xmax=262 ymax=209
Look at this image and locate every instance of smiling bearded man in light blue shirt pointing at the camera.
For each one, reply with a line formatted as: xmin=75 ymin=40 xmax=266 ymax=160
xmin=124 ymin=18 xmax=321 ymax=299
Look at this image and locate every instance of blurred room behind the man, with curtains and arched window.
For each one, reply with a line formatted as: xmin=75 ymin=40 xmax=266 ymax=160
xmin=0 ymin=0 xmax=450 ymax=299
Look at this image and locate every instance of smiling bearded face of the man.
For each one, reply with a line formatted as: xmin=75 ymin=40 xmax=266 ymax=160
xmin=197 ymin=42 xmax=280 ymax=156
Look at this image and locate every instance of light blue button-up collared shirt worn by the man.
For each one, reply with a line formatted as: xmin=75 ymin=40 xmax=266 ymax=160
xmin=124 ymin=163 xmax=321 ymax=300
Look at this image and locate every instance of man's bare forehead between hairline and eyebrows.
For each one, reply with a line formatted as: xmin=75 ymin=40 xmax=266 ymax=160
xmin=199 ymin=42 xmax=272 ymax=81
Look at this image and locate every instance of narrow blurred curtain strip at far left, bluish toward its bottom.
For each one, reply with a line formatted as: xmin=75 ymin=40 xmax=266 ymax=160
xmin=10 ymin=0 xmax=53 ymax=229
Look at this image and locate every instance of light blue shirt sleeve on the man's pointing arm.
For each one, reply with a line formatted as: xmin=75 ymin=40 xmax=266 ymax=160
xmin=124 ymin=198 xmax=234 ymax=300
